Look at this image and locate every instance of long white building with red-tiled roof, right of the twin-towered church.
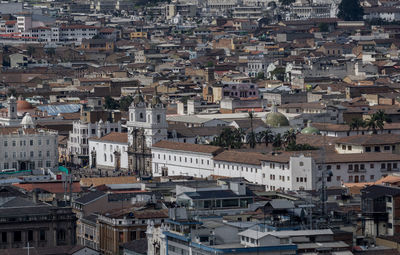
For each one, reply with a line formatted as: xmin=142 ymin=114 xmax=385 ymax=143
xmin=152 ymin=135 xmax=400 ymax=190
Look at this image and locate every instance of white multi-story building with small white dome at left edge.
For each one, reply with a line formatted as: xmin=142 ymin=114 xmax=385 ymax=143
xmin=0 ymin=113 xmax=58 ymax=170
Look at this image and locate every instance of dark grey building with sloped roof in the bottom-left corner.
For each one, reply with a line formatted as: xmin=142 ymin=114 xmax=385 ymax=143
xmin=0 ymin=186 xmax=76 ymax=249
